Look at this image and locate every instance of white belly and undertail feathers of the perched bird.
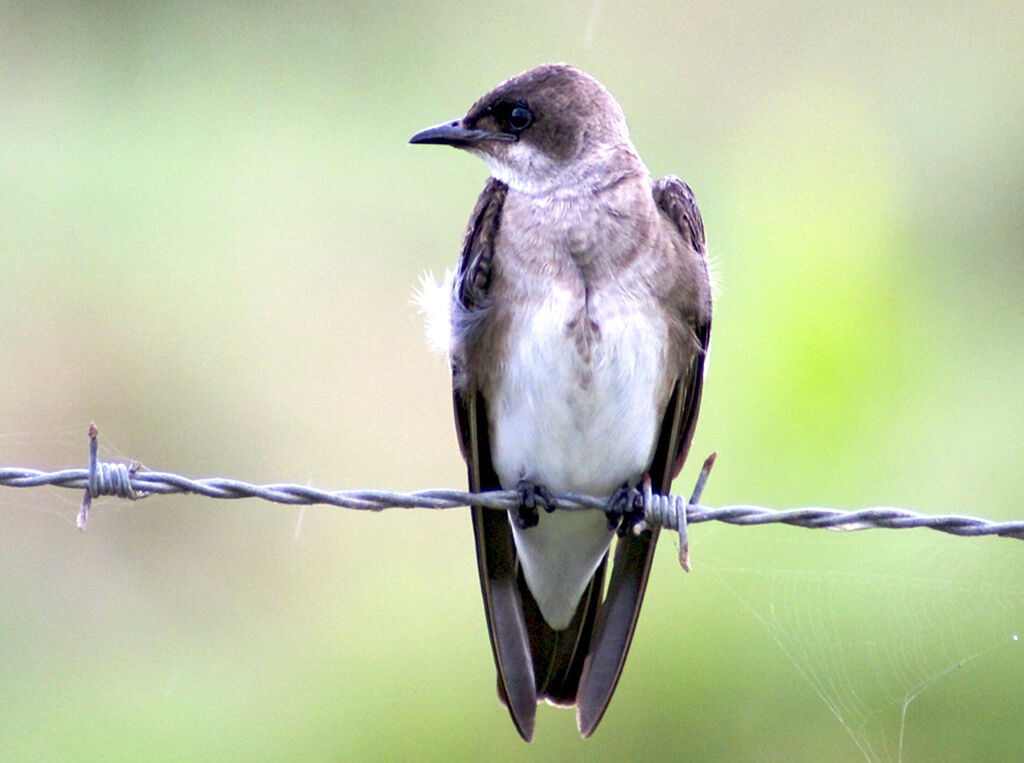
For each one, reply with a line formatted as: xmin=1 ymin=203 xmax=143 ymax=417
xmin=488 ymin=284 xmax=667 ymax=628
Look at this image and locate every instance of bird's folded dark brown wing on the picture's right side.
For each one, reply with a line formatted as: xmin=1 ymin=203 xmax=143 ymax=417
xmin=577 ymin=176 xmax=711 ymax=736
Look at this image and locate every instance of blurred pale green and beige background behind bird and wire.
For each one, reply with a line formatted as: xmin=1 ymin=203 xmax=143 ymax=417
xmin=0 ymin=0 xmax=1024 ymax=761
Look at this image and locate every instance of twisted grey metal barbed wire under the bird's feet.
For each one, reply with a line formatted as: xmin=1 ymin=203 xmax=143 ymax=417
xmin=0 ymin=424 xmax=1024 ymax=569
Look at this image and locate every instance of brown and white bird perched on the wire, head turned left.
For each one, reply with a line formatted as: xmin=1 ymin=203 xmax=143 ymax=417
xmin=410 ymin=63 xmax=712 ymax=741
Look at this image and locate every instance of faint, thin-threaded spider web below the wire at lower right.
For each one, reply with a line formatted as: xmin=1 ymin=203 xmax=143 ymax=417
xmin=699 ymin=529 xmax=1024 ymax=761
